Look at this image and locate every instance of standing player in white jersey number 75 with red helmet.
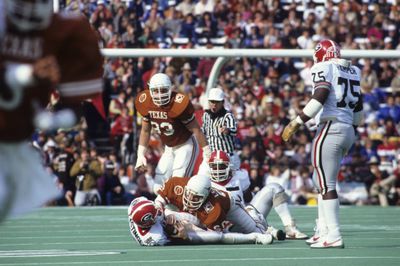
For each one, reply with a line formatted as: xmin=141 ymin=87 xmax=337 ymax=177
xmin=282 ymin=40 xmax=363 ymax=248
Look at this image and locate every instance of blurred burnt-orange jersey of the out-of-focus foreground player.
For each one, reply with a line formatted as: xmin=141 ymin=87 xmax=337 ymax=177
xmin=0 ymin=14 xmax=103 ymax=142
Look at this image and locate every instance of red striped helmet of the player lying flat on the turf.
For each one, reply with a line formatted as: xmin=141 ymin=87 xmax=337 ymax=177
xmin=128 ymin=197 xmax=161 ymax=228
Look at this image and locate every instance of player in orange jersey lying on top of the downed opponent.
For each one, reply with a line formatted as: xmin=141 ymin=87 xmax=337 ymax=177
xmin=155 ymin=175 xmax=272 ymax=241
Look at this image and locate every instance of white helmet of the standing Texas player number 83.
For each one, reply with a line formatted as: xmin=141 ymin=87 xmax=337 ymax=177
xmin=149 ymin=73 xmax=172 ymax=106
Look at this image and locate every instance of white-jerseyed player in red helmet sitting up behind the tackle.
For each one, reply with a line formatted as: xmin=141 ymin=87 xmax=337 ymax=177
xmin=208 ymin=150 xmax=307 ymax=240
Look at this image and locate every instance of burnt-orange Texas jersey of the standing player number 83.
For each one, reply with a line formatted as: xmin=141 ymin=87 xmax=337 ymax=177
xmin=135 ymin=90 xmax=195 ymax=147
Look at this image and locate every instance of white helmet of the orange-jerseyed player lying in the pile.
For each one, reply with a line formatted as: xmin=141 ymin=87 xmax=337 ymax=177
xmin=183 ymin=175 xmax=211 ymax=212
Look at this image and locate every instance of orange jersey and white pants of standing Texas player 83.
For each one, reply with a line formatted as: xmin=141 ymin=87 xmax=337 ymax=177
xmin=135 ymin=90 xmax=199 ymax=185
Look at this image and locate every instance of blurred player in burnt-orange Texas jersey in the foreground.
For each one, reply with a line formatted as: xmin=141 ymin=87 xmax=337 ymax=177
xmin=0 ymin=0 xmax=103 ymax=221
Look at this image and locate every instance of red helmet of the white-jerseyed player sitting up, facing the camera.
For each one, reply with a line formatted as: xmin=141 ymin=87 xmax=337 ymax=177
xmin=208 ymin=150 xmax=231 ymax=183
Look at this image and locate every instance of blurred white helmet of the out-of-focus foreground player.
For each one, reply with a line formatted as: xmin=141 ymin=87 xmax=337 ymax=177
xmin=4 ymin=0 xmax=53 ymax=31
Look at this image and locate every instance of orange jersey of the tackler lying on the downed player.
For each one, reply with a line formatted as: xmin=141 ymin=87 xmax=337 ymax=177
xmin=158 ymin=177 xmax=231 ymax=231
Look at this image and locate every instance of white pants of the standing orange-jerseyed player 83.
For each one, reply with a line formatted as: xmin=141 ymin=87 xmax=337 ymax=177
xmin=154 ymin=136 xmax=199 ymax=185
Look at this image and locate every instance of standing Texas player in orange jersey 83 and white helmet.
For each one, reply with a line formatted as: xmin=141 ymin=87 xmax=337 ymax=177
xmin=135 ymin=73 xmax=211 ymax=192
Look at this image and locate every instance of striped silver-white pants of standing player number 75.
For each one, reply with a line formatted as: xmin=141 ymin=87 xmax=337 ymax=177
xmin=311 ymin=121 xmax=355 ymax=195
